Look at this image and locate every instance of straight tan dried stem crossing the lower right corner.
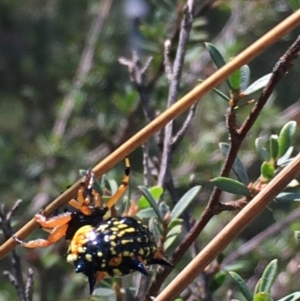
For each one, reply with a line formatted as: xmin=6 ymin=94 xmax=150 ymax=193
xmin=155 ymin=154 xmax=300 ymax=301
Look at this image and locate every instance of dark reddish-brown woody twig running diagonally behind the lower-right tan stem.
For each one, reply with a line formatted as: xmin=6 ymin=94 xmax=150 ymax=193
xmin=145 ymin=32 xmax=300 ymax=296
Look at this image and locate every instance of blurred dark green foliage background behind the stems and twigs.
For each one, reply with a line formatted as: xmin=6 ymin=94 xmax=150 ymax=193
xmin=0 ymin=0 xmax=300 ymax=301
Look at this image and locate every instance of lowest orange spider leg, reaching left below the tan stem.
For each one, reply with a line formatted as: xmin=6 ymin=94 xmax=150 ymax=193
xmin=13 ymin=224 xmax=68 ymax=249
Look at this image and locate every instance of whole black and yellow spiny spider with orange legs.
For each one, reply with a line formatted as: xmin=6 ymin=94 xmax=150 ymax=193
xmin=14 ymin=158 xmax=171 ymax=293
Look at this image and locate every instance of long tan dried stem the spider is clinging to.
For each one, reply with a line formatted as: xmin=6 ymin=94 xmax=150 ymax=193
xmin=0 ymin=10 xmax=300 ymax=258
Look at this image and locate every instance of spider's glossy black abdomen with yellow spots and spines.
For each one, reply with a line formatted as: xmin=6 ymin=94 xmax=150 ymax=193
xmin=67 ymin=217 xmax=170 ymax=290
